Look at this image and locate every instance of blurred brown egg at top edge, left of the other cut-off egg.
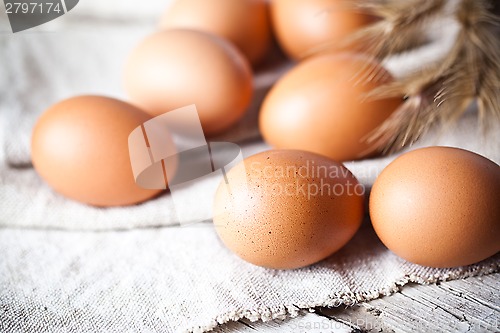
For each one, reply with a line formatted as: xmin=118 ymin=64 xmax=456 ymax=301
xmin=160 ymin=0 xmax=271 ymax=65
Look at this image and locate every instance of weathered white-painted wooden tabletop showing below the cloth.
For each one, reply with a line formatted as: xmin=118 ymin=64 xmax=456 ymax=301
xmin=214 ymin=273 xmax=500 ymax=333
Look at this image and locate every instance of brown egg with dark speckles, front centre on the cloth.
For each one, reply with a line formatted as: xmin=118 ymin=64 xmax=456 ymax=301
xmin=214 ymin=150 xmax=364 ymax=269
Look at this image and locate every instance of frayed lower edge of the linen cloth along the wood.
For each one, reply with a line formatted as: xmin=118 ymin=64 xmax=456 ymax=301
xmin=187 ymin=262 xmax=500 ymax=333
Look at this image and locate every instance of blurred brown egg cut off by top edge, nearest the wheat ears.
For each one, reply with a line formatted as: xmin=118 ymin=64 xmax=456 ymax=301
xmin=271 ymin=0 xmax=373 ymax=59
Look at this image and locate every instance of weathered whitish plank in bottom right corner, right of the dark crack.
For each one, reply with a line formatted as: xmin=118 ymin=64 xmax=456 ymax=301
xmin=323 ymin=274 xmax=500 ymax=332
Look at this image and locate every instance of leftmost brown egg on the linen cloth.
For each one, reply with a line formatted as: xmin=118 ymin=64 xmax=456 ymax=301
xmin=31 ymin=96 xmax=168 ymax=206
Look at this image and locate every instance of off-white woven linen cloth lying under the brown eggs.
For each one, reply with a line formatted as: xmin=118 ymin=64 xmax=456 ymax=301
xmin=0 ymin=0 xmax=500 ymax=332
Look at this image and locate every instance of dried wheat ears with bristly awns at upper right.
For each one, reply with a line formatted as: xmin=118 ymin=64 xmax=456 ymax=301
xmin=336 ymin=0 xmax=500 ymax=153
